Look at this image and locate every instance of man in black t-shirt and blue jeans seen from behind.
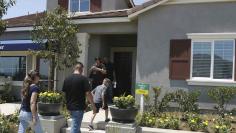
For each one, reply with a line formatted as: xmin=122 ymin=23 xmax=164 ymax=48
xmin=62 ymin=63 xmax=96 ymax=133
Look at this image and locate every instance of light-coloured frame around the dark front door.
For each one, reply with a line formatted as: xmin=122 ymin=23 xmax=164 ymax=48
xmin=110 ymin=47 xmax=137 ymax=95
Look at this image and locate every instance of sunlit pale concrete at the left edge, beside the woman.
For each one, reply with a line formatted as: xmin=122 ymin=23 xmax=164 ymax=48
xmin=0 ymin=103 xmax=21 ymax=115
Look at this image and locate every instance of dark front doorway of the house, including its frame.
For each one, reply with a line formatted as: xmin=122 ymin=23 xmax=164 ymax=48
xmin=111 ymin=47 xmax=136 ymax=96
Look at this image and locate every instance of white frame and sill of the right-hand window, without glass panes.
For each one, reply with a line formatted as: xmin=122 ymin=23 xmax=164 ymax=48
xmin=187 ymin=39 xmax=236 ymax=86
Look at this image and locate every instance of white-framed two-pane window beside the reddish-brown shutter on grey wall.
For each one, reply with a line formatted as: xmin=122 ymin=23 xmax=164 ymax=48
xmin=192 ymin=40 xmax=234 ymax=80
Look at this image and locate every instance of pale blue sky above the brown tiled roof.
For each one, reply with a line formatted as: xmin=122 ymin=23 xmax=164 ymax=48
xmin=3 ymin=0 xmax=146 ymax=19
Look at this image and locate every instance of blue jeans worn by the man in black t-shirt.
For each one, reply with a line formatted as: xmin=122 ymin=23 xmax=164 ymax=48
xmin=70 ymin=110 xmax=84 ymax=133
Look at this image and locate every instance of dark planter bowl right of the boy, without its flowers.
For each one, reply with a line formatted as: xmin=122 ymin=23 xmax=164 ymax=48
xmin=110 ymin=106 xmax=138 ymax=123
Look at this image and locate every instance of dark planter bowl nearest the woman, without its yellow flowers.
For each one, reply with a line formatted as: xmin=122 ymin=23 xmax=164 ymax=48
xmin=38 ymin=102 xmax=62 ymax=116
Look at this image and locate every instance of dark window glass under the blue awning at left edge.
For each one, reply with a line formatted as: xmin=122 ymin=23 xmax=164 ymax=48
xmin=0 ymin=56 xmax=26 ymax=81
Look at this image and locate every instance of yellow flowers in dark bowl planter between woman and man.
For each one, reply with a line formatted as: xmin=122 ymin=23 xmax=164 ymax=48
xmin=38 ymin=91 xmax=63 ymax=116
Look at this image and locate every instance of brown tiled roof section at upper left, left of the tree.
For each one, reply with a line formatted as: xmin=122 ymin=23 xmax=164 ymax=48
xmin=4 ymin=12 xmax=45 ymax=28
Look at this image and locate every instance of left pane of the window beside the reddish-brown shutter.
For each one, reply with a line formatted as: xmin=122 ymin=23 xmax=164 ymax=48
xmin=192 ymin=42 xmax=211 ymax=78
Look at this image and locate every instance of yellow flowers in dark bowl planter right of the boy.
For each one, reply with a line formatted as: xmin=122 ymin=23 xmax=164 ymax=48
xmin=110 ymin=95 xmax=138 ymax=123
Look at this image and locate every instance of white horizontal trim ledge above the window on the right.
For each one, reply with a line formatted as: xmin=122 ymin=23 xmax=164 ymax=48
xmin=187 ymin=33 xmax=236 ymax=39
